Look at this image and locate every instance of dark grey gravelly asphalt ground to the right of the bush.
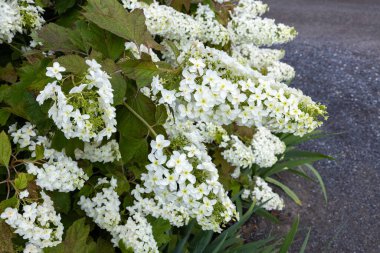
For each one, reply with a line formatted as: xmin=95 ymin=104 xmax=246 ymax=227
xmin=242 ymin=0 xmax=380 ymax=253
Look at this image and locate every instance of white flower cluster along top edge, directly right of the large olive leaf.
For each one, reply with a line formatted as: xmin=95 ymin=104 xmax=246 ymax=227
xmin=122 ymin=0 xmax=229 ymax=45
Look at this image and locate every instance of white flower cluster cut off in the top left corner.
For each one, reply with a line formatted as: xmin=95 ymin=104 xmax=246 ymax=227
xmin=0 ymin=0 xmax=45 ymax=44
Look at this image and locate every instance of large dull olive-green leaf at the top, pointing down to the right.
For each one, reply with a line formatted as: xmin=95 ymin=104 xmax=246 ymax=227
xmin=83 ymin=0 xmax=161 ymax=49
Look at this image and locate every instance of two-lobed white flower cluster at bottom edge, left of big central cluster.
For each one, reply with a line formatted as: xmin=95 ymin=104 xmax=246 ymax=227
xmin=78 ymin=178 xmax=158 ymax=253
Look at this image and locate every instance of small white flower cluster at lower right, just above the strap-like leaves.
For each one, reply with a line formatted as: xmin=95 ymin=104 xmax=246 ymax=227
xmin=241 ymin=177 xmax=285 ymax=211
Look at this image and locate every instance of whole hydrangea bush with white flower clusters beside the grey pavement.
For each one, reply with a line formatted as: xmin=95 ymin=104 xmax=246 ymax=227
xmin=0 ymin=0 xmax=330 ymax=253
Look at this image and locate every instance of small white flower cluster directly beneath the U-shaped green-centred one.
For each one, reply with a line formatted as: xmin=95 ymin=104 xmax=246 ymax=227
xmin=75 ymin=140 xmax=121 ymax=163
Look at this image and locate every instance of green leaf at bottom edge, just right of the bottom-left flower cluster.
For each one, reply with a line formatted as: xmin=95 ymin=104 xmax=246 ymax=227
xmin=44 ymin=218 xmax=96 ymax=253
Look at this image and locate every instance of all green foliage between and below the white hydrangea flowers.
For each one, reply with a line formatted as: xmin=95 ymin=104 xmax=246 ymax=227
xmin=0 ymin=0 xmax=332 ymax=253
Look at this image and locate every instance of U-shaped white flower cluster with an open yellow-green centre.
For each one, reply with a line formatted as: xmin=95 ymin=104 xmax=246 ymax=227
xmin=37 ymin=60 xmax=117 ymax=142
